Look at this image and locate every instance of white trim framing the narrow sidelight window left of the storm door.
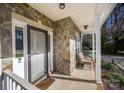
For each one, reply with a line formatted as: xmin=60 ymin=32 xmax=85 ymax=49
xmin=12 ymin=18 xmax=28 ymax=80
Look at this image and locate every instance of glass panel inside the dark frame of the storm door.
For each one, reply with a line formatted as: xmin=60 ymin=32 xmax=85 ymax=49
xmin=28 ymin=25 xmax=47 ymax=83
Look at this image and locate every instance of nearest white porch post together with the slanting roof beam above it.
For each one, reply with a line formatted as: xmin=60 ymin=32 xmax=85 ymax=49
xmin=94 ymin=4 xmax=116 ymax=83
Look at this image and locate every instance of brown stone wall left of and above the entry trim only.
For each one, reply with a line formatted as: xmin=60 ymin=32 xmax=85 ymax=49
xmin=0 ymin=3 xmax=54 ymax=66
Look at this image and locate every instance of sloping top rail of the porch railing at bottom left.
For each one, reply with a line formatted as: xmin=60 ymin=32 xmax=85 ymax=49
xmin=3 ymin=70 xmax=39 ymax=90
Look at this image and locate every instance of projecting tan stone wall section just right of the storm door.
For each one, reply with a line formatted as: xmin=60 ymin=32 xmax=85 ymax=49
xmin=54 ymin=17 xmax=80 ymax=75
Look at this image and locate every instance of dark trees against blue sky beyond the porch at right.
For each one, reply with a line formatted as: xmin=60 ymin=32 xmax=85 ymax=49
xmin=101 ymin=3 xmax=124 ymax=54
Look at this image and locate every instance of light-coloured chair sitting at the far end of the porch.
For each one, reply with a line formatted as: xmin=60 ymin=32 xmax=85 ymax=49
xmin=77 ymin=52 xmax=92 ymax=65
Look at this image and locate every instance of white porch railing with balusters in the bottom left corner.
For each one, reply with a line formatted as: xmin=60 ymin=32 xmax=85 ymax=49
xmin=1 ymin=70 xmax=38 ymax=90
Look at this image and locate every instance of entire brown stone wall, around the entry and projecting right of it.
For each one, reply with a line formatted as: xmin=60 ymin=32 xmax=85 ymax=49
xmin=0 ymin=4 xmax=79 ymax=75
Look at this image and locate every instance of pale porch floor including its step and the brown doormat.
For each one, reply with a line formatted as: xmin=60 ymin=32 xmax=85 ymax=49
xmin=36 ymin=65 xmax=97 ymax=90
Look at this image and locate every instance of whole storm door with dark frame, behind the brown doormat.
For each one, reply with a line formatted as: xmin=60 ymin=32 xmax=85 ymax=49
xmin=27 ymin=25 xmax=48 ymax=83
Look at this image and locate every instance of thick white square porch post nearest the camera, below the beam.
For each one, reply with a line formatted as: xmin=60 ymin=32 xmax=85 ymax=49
xmin=96 ymin=16 xmax=101 ymax=83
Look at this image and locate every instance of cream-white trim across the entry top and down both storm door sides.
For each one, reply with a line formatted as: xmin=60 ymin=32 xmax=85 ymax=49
xmin=12 ymin=12 xmax=54 ymax=80
